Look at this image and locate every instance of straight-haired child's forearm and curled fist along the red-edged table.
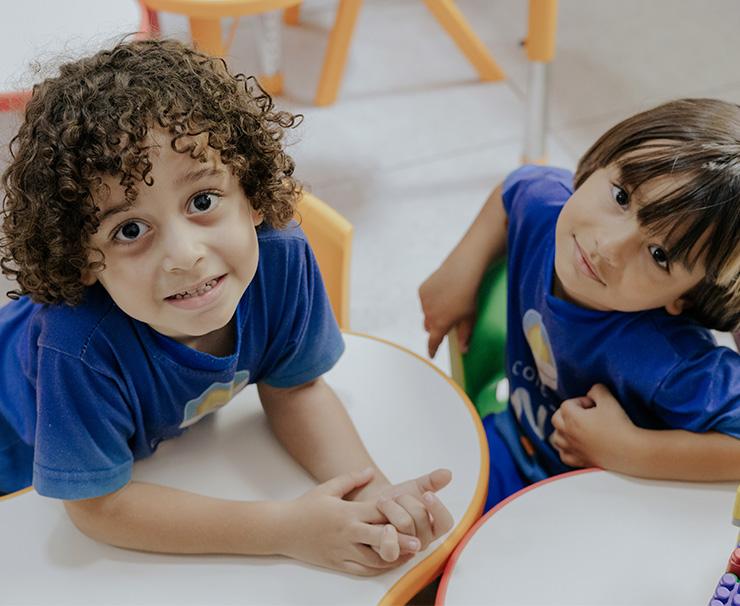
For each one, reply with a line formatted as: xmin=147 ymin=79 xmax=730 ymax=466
xmin=552 ymin=385 xmax=740 ymax=482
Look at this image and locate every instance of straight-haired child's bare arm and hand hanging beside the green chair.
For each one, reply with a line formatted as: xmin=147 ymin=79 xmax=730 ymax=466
xmin=419 ymin=184 xmax=508 ymax=358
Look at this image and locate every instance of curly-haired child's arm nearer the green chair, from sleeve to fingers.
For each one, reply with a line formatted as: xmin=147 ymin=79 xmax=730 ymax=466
xmin=258 ymin=379 xmax=453 ymax=553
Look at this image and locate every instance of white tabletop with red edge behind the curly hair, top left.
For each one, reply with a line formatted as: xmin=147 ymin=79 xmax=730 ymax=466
xmin=0 ymin=0 xmax=148 ymax=109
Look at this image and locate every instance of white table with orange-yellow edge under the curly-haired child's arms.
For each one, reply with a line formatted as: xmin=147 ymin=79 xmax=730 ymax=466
xmin=0 ymin=334 xmax=488 ymax=605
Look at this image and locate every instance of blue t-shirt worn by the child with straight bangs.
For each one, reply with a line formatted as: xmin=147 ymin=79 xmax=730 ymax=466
xmin=495 ymin=165 xmax=740 ymax=481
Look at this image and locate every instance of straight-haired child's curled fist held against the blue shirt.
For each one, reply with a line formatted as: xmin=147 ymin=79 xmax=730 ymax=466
xmin=551 ymin=384 xmax=637 ymax=471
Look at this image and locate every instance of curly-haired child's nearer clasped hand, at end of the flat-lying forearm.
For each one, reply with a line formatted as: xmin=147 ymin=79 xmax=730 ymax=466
xmin=281 ymin=469 xmax=419 ymax=576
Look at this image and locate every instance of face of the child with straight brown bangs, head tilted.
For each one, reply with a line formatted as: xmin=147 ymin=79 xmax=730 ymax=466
xmin=553 ymin=166 xmax=705 ymax=314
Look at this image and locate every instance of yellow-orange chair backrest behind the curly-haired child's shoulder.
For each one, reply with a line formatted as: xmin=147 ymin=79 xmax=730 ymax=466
xmin=296 ymin=192 xmax=354 ymax=330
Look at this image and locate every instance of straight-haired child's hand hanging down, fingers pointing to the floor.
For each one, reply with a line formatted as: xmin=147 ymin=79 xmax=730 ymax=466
xmin=419 ymin=260 xmax=478 ymax=358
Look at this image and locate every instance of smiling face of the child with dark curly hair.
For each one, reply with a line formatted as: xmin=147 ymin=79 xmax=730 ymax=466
xmin=86 ymin=130 xmax=262 ymax=349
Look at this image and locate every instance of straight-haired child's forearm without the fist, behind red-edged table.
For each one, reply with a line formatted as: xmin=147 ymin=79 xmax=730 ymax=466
xmin=608 ymin=428 xmax=740 ymax=482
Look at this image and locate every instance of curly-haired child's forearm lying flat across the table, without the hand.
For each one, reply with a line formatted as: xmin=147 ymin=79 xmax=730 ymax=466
xmin=65 ymin=482 xmax=292 ymax=555
